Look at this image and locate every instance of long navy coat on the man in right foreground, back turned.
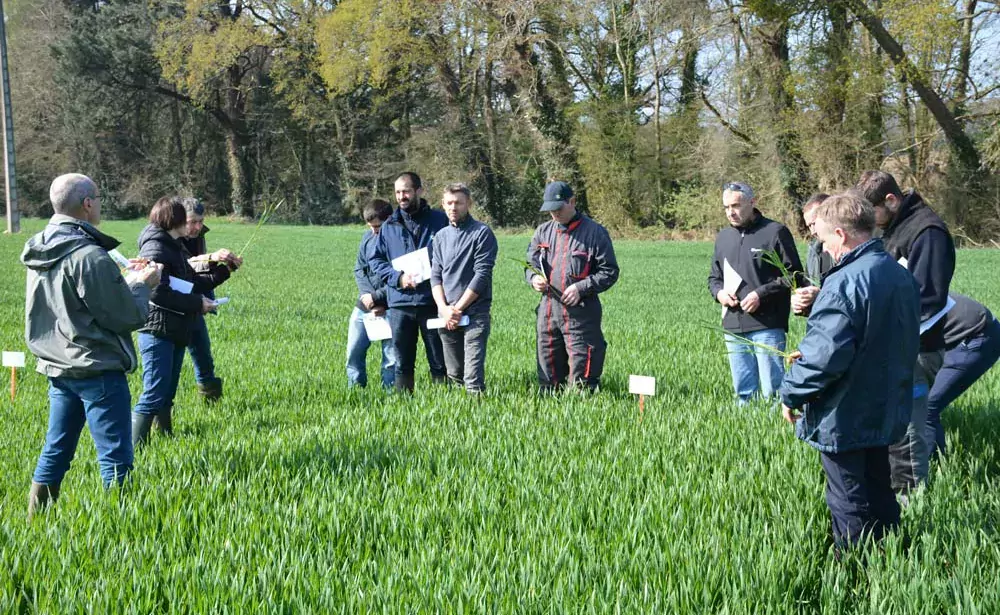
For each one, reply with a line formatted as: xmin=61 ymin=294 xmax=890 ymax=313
xmin=781 ymin=239 xmax=920 ymax=453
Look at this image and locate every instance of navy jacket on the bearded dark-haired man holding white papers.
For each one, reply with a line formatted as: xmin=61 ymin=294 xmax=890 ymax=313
xmin=368 ymin=199 xmax=448 ymax=308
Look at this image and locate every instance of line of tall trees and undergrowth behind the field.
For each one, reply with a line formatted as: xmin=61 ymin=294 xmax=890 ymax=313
xmin=7 ymin=0 xmax=1000 ymax=242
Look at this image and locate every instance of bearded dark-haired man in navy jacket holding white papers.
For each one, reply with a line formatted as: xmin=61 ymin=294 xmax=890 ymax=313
xmin=368 ymin=171 xmax=448 ymax=391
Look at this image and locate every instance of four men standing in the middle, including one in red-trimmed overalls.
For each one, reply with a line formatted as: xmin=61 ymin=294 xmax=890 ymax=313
xmin=347 ymin=172 xmax=619 ymax=394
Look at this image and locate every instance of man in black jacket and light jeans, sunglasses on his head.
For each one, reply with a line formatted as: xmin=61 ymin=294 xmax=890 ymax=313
xmin=708 ymin=182 xmax=802 ymax=403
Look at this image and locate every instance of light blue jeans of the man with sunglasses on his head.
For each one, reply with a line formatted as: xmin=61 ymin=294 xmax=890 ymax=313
xmin=726 ymin=329 xmax=785 ymax=403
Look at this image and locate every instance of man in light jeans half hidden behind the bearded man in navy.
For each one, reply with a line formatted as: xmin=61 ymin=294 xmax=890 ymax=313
xmin=347 ymin=199 xmax=396 ymax=388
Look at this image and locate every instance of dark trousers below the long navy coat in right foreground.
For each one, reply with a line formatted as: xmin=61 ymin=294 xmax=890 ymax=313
xmin=820 ymin=446 xmax=899 ymax=548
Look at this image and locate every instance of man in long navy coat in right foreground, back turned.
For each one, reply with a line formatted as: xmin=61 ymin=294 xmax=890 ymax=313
xmin=780 ymin=194 xmax=920 ymax=548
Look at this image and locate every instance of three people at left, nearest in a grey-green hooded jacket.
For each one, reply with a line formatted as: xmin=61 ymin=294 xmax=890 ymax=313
xmin=21 ymin=174 xmax=243 ymax=515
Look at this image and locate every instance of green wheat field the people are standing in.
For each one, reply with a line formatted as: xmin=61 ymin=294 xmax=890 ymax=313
xmin=0 ymin=220 xmax=1000 ymax=614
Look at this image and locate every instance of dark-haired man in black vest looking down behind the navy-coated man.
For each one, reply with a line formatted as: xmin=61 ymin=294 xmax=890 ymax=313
xmin=856 ymin=171 xmax=955 ymax=493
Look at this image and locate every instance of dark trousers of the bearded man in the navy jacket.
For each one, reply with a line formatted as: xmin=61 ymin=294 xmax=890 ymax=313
xmin=389 ymin=305 xmax=445 ymax=389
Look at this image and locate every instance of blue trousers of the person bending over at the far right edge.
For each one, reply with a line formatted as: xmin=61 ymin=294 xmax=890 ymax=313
xmin=927 ymin=318 xmax=1000 ymax=454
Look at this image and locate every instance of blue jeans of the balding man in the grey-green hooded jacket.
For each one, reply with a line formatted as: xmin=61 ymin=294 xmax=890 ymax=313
xmin=33 ymin=372 xmax=132 ymax=486
